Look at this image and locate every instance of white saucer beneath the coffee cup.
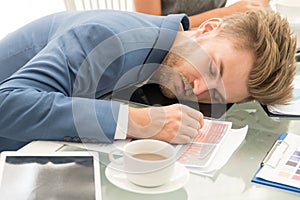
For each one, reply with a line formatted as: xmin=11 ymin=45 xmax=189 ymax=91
xmin=105 ymin=159 xmax=190 ymax=194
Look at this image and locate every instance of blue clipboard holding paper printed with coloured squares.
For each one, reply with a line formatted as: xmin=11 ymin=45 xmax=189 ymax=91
xmin=252 ymin=133 xmax=300 ymax=193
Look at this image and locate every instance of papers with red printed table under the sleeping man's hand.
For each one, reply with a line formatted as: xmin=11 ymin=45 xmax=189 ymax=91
xmin=176 ymin=120 xmax=248 ymax=177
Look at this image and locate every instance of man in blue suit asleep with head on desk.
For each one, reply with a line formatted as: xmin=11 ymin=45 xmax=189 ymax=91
xmin=0 ymin=10 xmax=296 ymax=150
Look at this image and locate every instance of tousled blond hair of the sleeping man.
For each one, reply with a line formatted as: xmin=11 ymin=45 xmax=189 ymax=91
xmin=219 ymin=10 xmax=296 ymax=105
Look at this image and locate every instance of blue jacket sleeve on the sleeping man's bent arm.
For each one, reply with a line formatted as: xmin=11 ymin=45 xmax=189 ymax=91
xmin=0 ymin=24 xmax=124 ymax=142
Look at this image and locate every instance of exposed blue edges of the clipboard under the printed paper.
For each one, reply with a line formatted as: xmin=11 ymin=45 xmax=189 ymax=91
xmin=251 ymin=133 xmax=300 ymax=193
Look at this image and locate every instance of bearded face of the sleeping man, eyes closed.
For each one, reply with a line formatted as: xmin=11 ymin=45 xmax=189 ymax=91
xmin=159 ymin=34 xmax=254 ymax=103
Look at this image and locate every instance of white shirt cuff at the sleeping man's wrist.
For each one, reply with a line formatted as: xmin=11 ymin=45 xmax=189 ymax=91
xmin=114 ymin=104 xmax=128 ymax=140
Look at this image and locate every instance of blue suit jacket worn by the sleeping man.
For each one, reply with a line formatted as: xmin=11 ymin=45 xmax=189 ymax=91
xmin=0 ymin=10 xmax=189 ymax=151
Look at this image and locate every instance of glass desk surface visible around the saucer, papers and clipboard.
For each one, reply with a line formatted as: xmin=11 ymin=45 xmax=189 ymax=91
xmin=15 ymin=101 xmax=300 ymax=200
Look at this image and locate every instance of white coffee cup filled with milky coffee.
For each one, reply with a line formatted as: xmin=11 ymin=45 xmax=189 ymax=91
xmin=109 ymin=139 xmax=176 ymax=187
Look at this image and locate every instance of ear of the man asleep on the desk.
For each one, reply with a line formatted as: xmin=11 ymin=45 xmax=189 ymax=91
xmin=194 ymin=18 xmax=223 ymax=37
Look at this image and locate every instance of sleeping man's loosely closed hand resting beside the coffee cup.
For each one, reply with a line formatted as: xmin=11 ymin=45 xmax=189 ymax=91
xmin=127 ymin=104 xmax=204 ymax=144
